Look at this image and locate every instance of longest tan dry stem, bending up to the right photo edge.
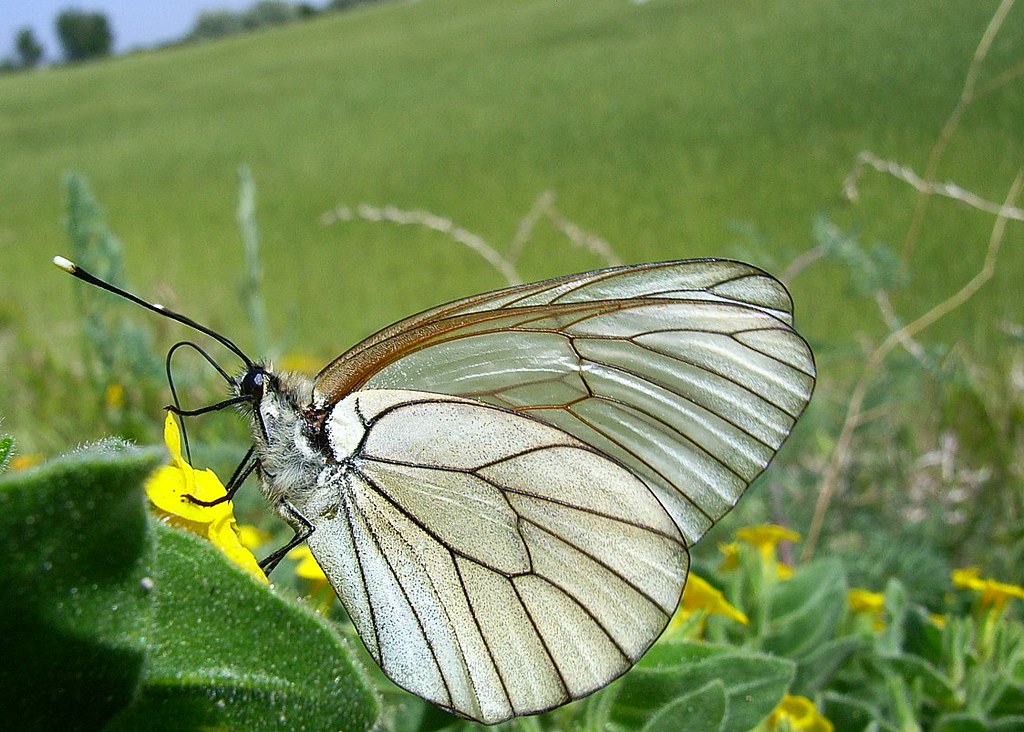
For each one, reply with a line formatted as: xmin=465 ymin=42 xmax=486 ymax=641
xmin=803 ymin=169 xmax=1024 ymax=561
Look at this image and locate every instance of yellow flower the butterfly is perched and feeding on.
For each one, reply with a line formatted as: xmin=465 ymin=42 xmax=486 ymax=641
xmin=145 ymin=413 xmax=267 ymax=583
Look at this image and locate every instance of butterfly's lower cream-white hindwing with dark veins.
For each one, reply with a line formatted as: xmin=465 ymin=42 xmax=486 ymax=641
xmin=294 ymin=391 xmax=688 ymax=723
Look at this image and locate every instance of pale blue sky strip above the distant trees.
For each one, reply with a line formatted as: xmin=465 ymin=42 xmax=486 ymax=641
xmin=0 ymin=0 xmax=296 ymax=61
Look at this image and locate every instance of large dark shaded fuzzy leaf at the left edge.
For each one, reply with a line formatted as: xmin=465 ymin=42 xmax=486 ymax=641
xmin=0 ymin=442 xmax=163 ymax=729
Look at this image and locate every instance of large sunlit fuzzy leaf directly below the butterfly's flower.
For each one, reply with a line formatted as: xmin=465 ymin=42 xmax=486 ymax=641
xmin=108 ymin=521 xmax=379 ymax=730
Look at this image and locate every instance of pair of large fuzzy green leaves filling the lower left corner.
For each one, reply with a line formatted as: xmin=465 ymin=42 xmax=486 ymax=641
xmin=0 ymin=442 xmax=378 ymax=730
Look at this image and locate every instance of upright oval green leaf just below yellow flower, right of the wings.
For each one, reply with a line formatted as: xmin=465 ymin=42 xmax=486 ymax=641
xmin=762 ymin=560 xmax=847 ymax=658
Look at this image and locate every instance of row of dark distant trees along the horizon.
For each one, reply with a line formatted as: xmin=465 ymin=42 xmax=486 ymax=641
xmin=0 ymin=0 xmax=380 ymax=71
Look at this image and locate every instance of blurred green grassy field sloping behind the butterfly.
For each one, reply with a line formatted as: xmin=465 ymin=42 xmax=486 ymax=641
xmin=0 ymin=0 xmax=1024 ymax=446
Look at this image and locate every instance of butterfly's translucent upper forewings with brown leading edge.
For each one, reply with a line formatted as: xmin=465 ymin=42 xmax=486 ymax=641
xmin=316 ymin=260 xmax=814 ymax=545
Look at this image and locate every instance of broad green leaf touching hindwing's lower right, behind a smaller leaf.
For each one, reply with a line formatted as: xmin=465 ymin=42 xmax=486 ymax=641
xmin=609 ymin=641 xmax=794 ymax=730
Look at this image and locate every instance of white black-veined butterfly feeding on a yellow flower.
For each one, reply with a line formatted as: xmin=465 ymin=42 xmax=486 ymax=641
xmin=54 ymin=257 xmax=815 ymax=724
